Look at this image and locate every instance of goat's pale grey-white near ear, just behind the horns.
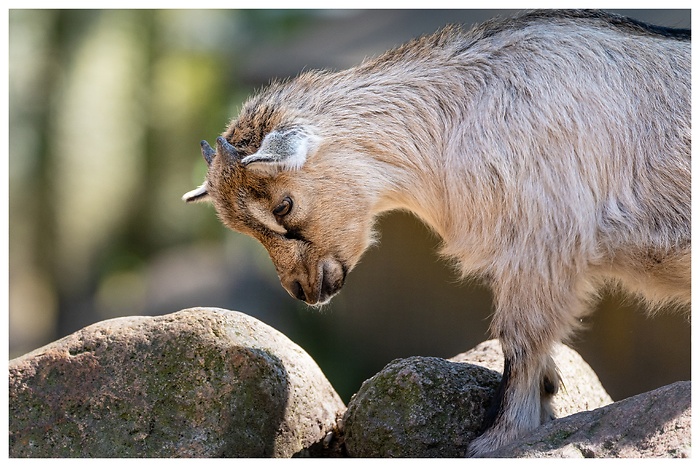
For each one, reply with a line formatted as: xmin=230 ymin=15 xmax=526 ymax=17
xmin=241 ymin=128 xmax=319 ymax=173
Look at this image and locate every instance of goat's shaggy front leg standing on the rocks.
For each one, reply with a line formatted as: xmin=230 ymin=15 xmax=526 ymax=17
xmin=469 ymin=273 xmax=586 ymax=456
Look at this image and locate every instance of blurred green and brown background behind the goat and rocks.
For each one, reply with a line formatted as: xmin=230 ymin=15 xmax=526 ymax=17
xmin=9 ymin=10 xmax=690 ymax=402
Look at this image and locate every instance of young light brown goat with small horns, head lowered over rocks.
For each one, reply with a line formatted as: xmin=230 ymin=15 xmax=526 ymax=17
xmin=184 ymin=11 xmax=691 ymax=455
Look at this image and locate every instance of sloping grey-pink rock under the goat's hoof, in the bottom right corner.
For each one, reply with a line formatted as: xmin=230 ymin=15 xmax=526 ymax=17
xmin=489 ymin=381 xmax=691 ymax=458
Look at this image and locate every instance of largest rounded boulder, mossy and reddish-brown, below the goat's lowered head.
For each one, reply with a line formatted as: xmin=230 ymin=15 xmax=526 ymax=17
xmin=9 ymin=308 xmax=345 ymax=457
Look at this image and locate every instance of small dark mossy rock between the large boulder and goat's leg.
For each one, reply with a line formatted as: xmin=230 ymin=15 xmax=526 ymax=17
xmin=343 ymin=357 xmax=500 ymax=457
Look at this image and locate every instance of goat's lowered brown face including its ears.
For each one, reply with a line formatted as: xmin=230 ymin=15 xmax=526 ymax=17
xmin=183 ymin=124 xmax=373 ymax=305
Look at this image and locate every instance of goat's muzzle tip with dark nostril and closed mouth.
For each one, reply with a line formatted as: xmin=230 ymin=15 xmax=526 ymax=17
xmin=285 ymin=259 xmax=348 ymax=306
